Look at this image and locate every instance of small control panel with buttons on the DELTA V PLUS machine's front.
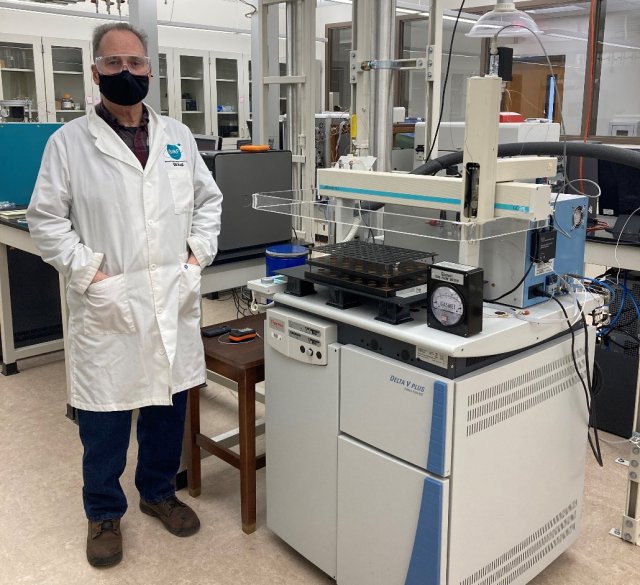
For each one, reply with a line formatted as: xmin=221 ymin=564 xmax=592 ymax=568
xmin=265 ymin=307 xmax=338 ymax=366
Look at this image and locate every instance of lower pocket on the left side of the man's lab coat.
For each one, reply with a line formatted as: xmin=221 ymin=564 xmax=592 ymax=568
xmin=84 ymin=274 xmax=136 ymax=335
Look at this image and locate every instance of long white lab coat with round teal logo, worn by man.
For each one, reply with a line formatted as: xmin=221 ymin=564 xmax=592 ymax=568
xmin=27 ymin=108 xmax=222 ymax=411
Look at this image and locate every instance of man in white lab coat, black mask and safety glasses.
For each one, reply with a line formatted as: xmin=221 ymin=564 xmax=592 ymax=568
xmin=27 ymin=23 xmax=222 ymax=566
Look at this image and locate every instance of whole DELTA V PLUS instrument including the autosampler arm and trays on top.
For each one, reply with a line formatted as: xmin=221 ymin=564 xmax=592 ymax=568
xmin=254 ymin=76 xmax=600 ymax=585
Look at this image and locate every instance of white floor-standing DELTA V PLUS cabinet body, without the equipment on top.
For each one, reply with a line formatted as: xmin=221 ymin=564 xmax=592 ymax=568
xmin=265 ymin=294 xmax=594 ymax=585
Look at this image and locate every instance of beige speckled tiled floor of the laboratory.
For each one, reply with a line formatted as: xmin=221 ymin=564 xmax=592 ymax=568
xmin=0 ymin=301 xmax=640 ymax=585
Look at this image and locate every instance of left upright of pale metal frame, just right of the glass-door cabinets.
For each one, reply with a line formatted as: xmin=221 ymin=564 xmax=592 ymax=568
xmin=251 ymin=3 xmax=280 ymax=148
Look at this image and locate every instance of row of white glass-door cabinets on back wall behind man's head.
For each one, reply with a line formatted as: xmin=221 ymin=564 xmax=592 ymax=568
xmin=0 ymin=34 xmax=250 ymax=140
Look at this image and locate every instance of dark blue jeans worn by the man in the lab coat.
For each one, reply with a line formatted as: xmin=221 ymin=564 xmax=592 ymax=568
xmin=77 ymin=391 xmax=188 ymax=520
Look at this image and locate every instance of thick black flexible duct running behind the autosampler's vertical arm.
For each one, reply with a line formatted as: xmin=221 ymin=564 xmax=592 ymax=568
xmin=410 ymin=142 xmax=640 ymax=175
